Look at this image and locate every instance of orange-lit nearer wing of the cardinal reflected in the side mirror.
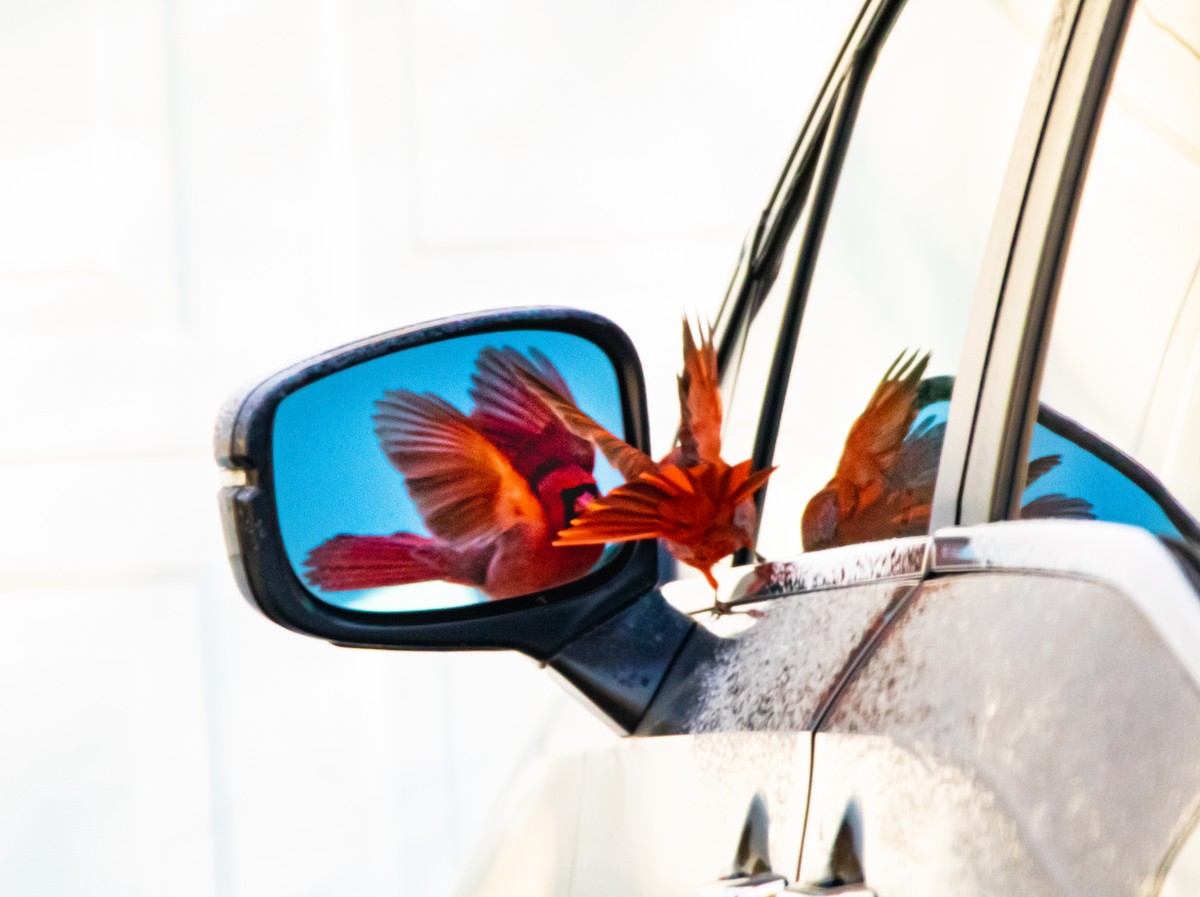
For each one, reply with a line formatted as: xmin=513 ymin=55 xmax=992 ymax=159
xmin=373 ymin=390 xmax=542 ymax=542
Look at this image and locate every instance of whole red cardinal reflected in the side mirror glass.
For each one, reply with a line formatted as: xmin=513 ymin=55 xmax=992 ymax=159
xmin=305 ymin=348 xmax=602 ymax=598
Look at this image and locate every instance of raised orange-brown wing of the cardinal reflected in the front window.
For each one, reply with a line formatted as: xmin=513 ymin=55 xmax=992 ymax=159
xmin=838 ymin=351 xmax=930 ymax=486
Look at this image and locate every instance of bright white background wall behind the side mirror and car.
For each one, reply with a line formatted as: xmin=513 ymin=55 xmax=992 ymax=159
xmin=0 ymin=0 xmax=856 ymax=897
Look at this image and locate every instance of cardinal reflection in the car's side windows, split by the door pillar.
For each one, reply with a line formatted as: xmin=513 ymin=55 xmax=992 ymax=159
xmin=800 ymin=351 xmax=1093 ymax=552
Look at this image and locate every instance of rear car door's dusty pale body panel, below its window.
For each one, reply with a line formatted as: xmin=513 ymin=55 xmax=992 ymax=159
xmin=799 ymin=523 xmax=1200 ymax=896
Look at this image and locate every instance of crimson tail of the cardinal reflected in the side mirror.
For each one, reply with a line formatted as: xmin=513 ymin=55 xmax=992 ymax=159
xmin=304 ymin=532 xmax=462 ymax=591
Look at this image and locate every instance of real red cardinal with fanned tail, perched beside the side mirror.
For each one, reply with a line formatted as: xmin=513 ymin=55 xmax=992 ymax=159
xmin=522 ymin=319 xmax=774 ymax=589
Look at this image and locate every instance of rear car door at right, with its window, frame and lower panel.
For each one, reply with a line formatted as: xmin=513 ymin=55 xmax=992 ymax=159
xmin=798 ymin=2 xmax=1200 ymax=895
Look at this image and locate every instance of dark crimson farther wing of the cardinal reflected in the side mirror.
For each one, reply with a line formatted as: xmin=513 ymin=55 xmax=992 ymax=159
xmin=470 ymin=347 xmax=595 ymax=470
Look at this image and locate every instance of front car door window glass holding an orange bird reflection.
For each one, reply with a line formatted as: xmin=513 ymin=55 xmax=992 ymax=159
xmin=758 ymin=0 xmax=1051 ymax=558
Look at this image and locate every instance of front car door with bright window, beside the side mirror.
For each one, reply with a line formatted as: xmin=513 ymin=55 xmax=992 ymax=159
xmin=535 ymin=0 xmax=1050 ymax=895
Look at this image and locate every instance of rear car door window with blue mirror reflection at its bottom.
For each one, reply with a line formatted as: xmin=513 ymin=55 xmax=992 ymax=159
xmin=1022 ymin=0 xmax=1200 ymax=541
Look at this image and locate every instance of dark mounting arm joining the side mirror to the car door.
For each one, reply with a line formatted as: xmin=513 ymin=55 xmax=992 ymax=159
xmin=546 ymin=589 xmax=707 ymax=733
